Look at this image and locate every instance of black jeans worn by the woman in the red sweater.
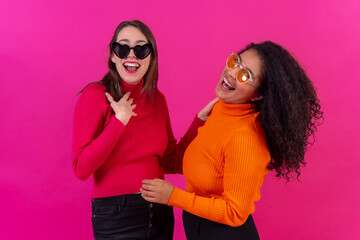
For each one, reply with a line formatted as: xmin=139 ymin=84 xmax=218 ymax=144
xmin=91 ymin=194 xmax=174 ymax=240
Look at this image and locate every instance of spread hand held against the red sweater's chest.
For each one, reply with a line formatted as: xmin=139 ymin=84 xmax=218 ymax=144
xmin=105 ymin=92 xmax=137 ymax=126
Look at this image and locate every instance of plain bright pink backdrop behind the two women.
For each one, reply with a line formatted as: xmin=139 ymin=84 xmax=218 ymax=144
xmin=0 ymin=0 xmax=360 ymax=240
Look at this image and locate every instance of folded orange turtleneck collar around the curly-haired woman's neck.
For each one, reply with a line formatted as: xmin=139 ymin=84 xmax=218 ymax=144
xmin=214 ymin=100 xmax=258 ymax=117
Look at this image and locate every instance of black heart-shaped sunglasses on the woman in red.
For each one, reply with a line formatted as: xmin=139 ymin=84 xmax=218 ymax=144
xmin=111 ymin=42 xmax=152 ymax=59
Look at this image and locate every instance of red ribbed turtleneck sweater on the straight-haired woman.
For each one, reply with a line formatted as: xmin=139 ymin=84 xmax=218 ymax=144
xmin=73 ymin=79 xmax=204 ymax=198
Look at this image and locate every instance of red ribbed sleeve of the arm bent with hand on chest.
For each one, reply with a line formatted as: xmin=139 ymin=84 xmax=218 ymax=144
xmin=73 ymin=84 xmax=125 ymax=180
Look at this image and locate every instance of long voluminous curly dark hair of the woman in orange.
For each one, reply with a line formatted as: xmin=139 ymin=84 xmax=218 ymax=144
xmin=240 ymin=41 xmax=323 ymax=181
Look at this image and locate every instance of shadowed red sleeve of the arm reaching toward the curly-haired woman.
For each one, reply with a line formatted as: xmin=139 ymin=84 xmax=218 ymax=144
xmin=161 ymin=112 xmax=205 ymax=173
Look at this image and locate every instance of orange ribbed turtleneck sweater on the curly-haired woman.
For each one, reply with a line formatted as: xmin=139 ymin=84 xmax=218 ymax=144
xmin=168 ymin=101 xmax=270 ymax=226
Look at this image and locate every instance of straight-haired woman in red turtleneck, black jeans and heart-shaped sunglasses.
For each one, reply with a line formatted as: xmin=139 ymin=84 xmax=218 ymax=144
xmin=73 ymin=20 xmax=215 ymax=239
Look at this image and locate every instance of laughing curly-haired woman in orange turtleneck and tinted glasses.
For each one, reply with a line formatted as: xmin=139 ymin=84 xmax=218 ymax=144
xmin=141 ymin=41 xmax=322 ymax=239
